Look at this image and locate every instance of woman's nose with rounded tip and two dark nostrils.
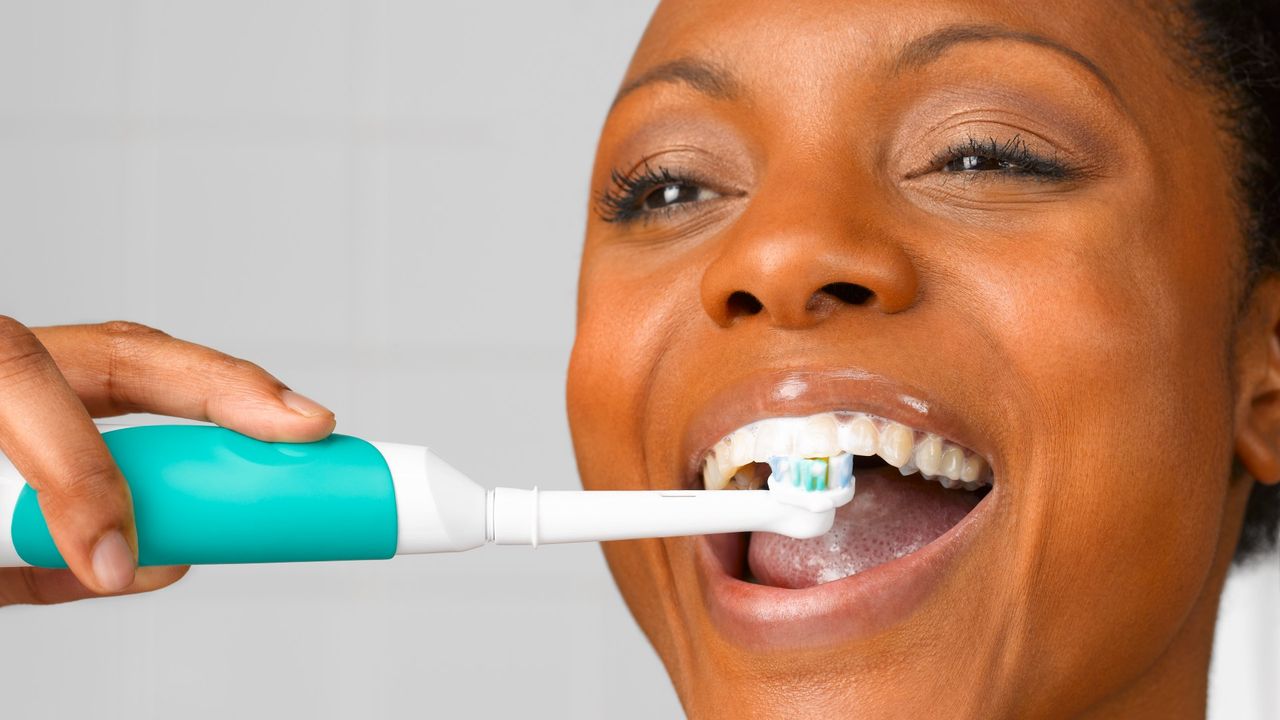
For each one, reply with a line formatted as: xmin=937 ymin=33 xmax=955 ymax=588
xmin=701 ymin=203 xmax=919 ymax=328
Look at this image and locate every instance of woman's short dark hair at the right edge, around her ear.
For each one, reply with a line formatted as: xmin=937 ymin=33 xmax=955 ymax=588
xmin=1172 ymin=0 xmax=1280 ymax=564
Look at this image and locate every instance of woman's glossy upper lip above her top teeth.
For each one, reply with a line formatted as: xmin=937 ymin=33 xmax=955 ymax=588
xmin=680 ymin=368 xmax=1000 ymax=488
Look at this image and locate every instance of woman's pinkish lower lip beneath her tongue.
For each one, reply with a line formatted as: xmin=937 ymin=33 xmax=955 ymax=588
xmin=694 ymin=488 xmax=997 ymax=650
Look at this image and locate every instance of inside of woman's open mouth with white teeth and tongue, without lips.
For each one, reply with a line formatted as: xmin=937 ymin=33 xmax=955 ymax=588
xmin=691 ymin=410 xmax=995 ymax=588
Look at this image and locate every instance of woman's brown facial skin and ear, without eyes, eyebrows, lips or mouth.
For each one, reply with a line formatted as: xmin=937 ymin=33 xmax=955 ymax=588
xmin=568 ymin=0 xmax=1280 ymax=719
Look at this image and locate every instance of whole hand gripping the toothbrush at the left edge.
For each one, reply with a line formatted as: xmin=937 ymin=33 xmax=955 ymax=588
xmin=0 ymin=315 xmax=334 ymax=606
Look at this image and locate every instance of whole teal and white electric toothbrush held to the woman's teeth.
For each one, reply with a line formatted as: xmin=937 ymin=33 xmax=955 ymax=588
xmin=0 ymin=425 xmax=854 ymax=568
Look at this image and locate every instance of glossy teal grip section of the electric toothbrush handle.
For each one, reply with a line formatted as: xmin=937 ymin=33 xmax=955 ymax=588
xmin=12 ymin=425 xmax=397 ymax=568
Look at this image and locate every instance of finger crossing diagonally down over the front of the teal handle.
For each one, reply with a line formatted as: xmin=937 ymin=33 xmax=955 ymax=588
xmin=0 ymin=316 xmax=137 ymax=593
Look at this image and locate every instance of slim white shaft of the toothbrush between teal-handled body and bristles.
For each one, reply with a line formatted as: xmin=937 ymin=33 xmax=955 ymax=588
xmin=488 ymin=488 xmax=836 ymax=546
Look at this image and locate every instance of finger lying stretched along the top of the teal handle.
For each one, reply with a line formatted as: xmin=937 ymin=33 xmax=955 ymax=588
xmin=35 ymin=322 xmax=335 ymax=442
